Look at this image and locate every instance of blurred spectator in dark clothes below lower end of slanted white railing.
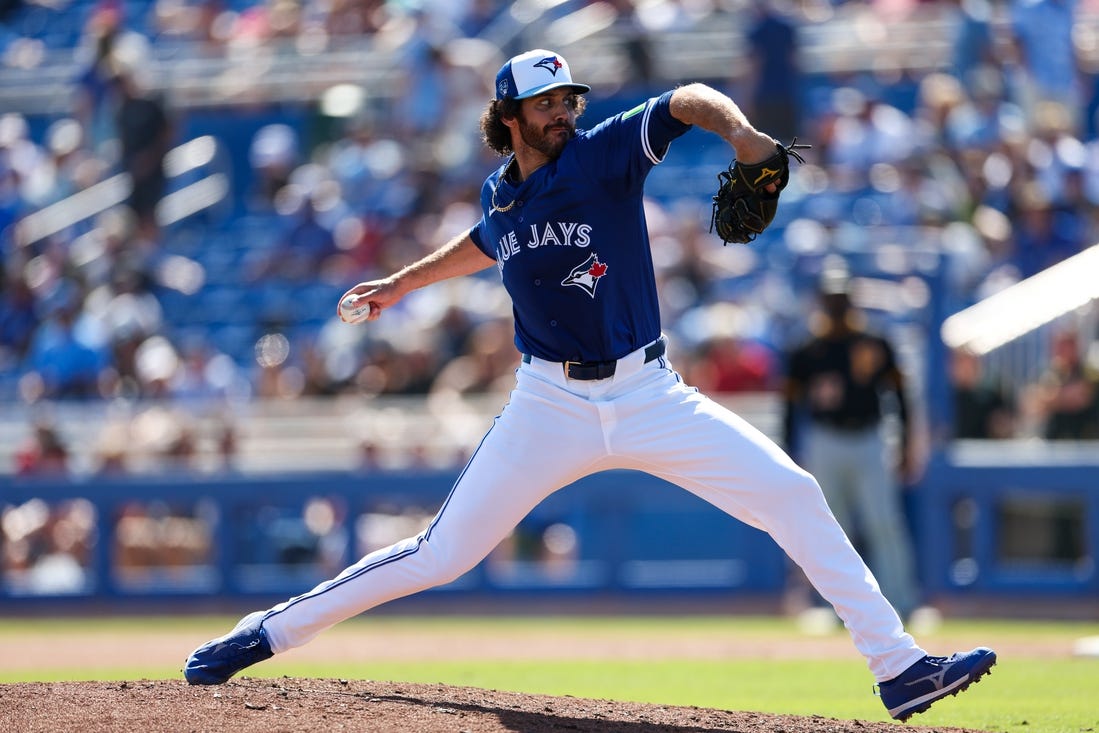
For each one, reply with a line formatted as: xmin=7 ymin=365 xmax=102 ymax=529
xmin=951 ymin=348 xmax=1015 ymax=440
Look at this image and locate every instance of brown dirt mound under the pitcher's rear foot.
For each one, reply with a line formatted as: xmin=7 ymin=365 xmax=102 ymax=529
xmin=0 ymin=677 xmax=989 ymax=733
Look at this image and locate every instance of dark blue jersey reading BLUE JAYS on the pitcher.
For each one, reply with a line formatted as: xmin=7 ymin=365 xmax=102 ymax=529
xmin=469 ymin=91 xmax=690 ymax=362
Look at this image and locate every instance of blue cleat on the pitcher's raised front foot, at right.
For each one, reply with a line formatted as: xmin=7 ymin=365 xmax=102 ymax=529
xmin=878 ymin=646 xmax=996 ymax=722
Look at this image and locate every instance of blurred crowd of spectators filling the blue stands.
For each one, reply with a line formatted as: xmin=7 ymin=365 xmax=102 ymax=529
xmin=0 ymin=0 xmax=1099 ymax=483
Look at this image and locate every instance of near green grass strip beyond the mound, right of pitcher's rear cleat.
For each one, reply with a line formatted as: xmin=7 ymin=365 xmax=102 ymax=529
xmin=271 ymin=660 xmax=1099 ymax=733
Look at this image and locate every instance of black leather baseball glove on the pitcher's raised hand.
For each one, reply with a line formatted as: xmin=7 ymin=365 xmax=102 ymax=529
xmin=710 ymin=137 xmax=812 ymax=244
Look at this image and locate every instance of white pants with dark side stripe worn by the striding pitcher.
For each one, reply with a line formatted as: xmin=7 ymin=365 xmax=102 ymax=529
xmin=264 ymin=349 xmax=925 ymax=681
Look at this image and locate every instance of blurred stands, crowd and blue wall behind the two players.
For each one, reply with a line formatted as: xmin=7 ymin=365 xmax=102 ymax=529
xmin=0 ymin=0 xmax=1099 ymax=618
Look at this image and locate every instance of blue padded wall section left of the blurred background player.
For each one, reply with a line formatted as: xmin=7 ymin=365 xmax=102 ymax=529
xmin=0 ymin=471 xmax=785 ymax=606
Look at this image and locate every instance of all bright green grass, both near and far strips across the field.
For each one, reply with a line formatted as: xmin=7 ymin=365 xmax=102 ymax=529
xmin=0 ymin=615 xmax=1099 ymax=733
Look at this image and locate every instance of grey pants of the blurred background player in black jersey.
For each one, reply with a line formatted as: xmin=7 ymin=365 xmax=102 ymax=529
xmin=806 ymin=424 xmax=920 ymax=614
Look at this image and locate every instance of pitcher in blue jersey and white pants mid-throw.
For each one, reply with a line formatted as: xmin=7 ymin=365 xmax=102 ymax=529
xmin=184 ymin=49 xmax=996 ymax=720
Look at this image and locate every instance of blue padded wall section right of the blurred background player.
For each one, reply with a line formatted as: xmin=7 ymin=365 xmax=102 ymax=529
xmin=917 ymin=452 xmax=1099 ymax=601
